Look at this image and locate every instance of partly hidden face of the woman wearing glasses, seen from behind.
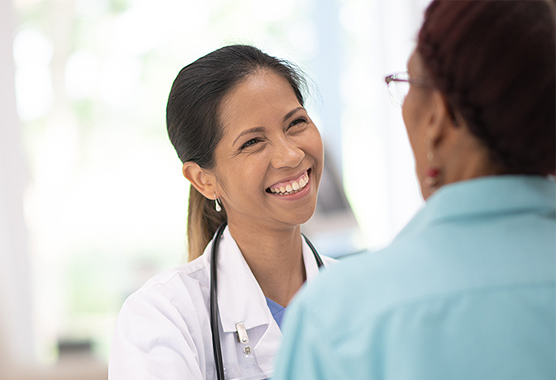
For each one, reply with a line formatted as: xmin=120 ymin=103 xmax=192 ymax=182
xmin=402 ymin=52 xmax=433 ymax=199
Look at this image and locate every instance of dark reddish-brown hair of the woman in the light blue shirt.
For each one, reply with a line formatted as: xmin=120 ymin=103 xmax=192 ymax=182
xmin=416 ymin=0 xmax=556 ymax=175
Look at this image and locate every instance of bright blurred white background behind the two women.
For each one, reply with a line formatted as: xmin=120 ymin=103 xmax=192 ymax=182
xmin=0 ymin=0 xmax=429 ymax=380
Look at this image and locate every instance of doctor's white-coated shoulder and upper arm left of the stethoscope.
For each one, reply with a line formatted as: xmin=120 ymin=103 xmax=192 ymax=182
xmin=110 ymin=254 xmax=213 ymax=379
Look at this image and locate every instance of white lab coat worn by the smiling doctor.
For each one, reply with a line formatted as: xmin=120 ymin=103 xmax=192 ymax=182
xmin=109 ymin=228 xmax=335 ymax=380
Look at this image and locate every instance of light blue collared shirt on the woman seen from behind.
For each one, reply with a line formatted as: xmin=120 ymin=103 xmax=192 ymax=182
xmin=273 ymin=176 xmax=556 ymax=380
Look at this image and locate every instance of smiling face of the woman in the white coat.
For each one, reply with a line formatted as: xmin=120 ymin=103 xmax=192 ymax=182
xmin=214 ymin=70 xmax=324 ymax=228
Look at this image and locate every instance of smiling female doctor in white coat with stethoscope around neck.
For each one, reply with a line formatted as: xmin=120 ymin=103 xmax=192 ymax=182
xmin=109 ymin=45 xmax=331 ymax=380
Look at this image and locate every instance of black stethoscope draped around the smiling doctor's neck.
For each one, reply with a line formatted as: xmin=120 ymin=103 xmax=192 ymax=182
xmin=210 ymin=222 xmax=323 ymax=380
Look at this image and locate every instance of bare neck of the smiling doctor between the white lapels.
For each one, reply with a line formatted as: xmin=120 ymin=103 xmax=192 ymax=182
xmin=229 ymin=223 xmax=306 ymax=306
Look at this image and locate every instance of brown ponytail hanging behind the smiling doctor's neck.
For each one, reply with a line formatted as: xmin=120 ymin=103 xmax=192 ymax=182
xmin=187 ymin=185 xmax=227 ymax=261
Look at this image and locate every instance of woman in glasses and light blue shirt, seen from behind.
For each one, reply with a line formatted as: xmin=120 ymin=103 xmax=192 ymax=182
xmin=274 ymin=0 xmax=556 ymax=380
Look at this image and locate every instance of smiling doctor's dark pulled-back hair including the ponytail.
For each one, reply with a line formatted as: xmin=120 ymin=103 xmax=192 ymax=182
xmin=166 ymin=45 xmax=305 ymax=261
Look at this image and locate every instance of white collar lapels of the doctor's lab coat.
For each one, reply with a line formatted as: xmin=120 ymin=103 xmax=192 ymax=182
xmin=205 ymin=227 xmax=319 ymax=332
